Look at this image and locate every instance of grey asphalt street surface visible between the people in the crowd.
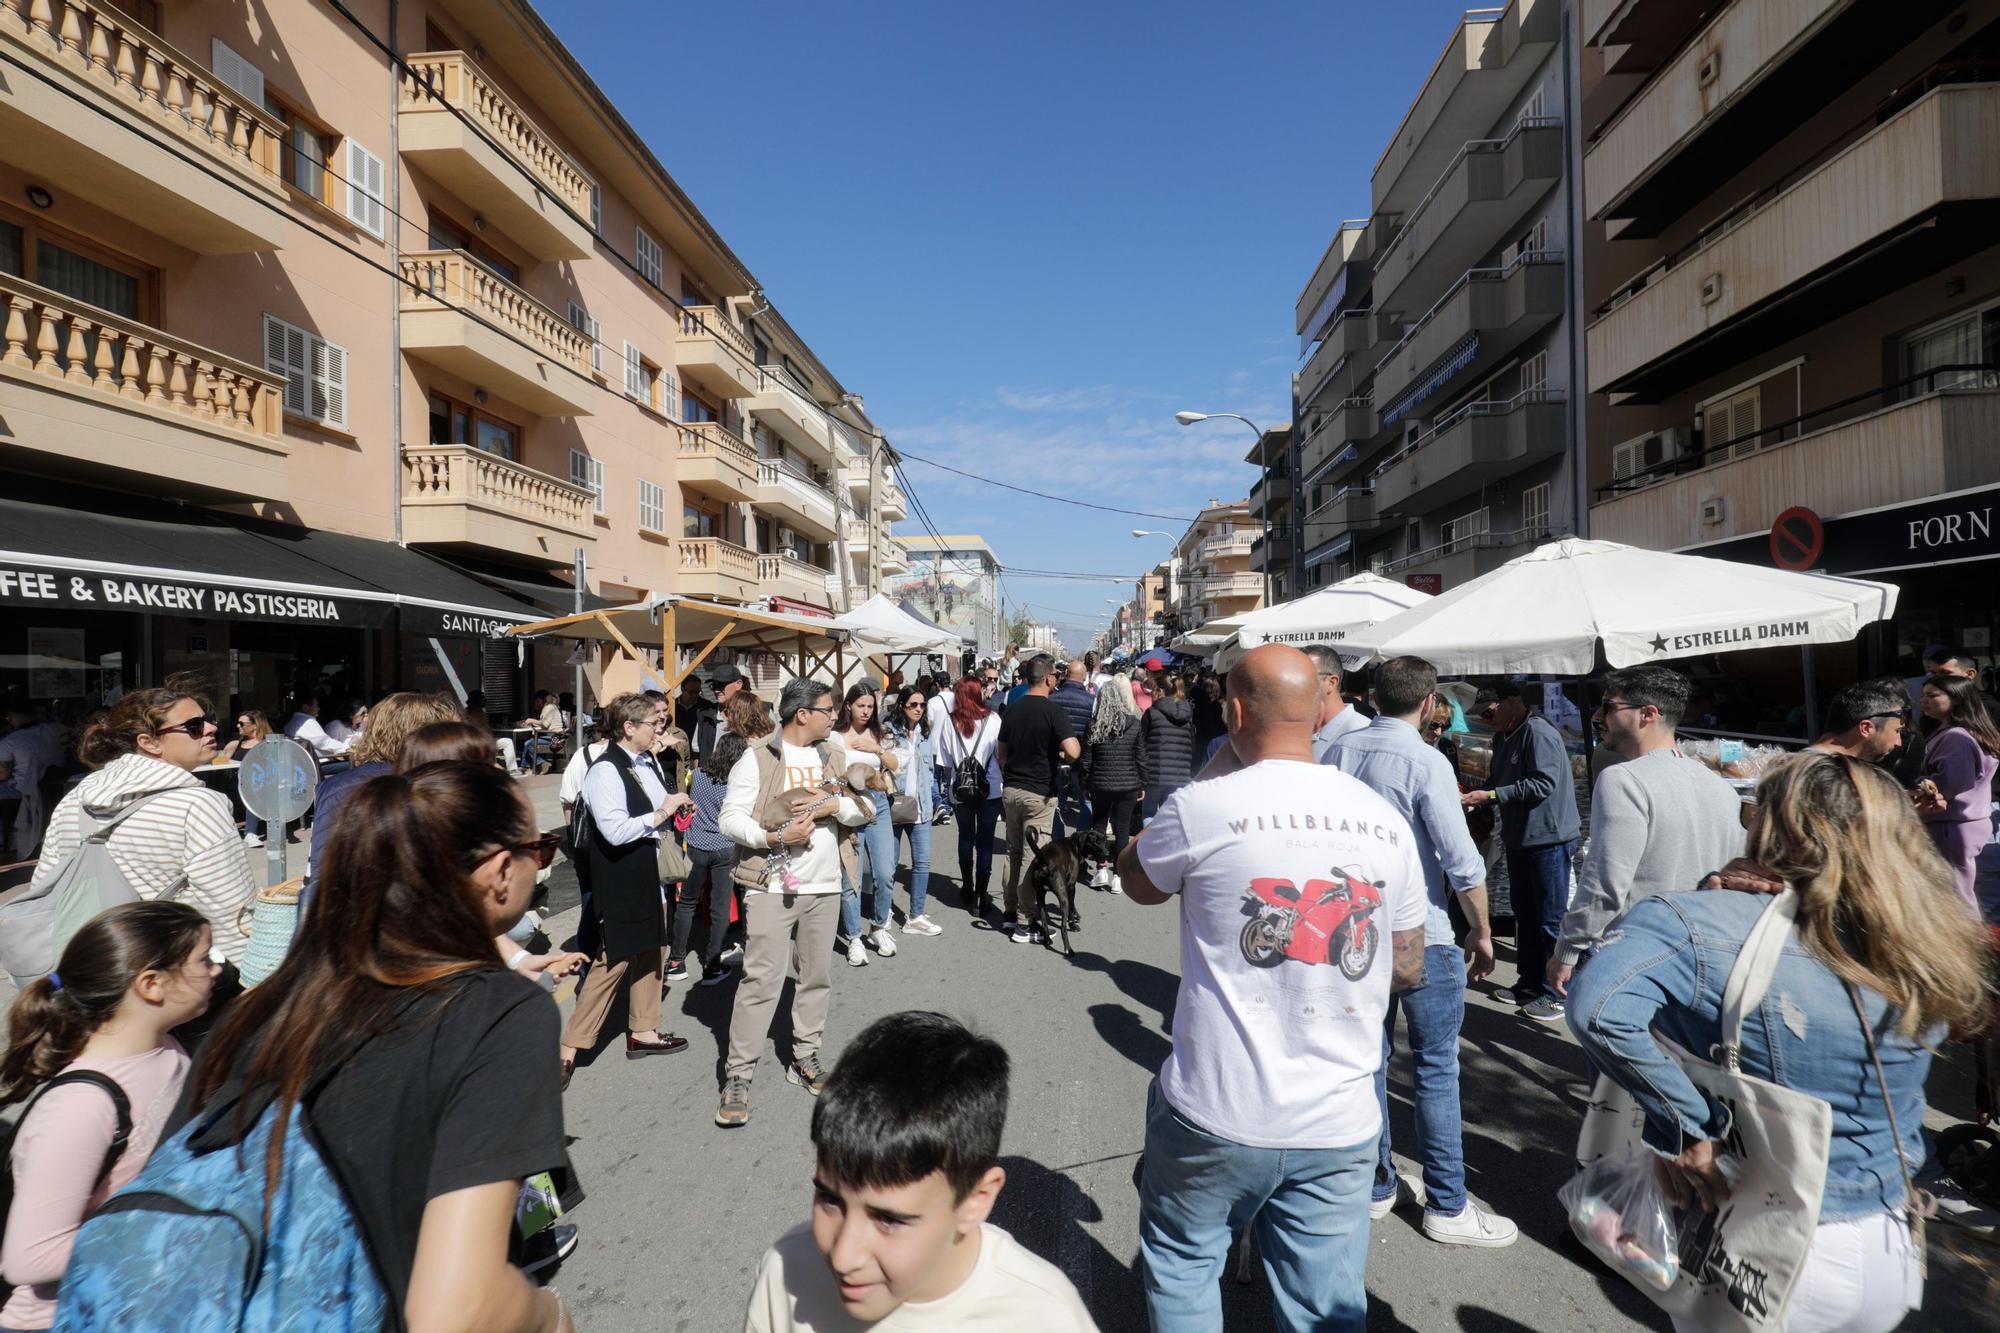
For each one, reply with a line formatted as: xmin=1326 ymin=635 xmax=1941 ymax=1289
xmin=538 ymin=793 xmax=1992 ymax=1333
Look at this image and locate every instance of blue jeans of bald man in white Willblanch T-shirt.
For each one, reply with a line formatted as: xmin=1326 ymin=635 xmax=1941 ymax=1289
xmin=1138 ymin=1083 xmax=1376 ymax=1333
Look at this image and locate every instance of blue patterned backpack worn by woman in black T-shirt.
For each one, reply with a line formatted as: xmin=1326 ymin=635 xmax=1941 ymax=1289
xmin=52 ymin=1071 xmax=400 ymax=1333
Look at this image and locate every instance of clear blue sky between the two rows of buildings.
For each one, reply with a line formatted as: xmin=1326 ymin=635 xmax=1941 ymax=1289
xmin=542 ymin=0 xmax=1464 ymax=644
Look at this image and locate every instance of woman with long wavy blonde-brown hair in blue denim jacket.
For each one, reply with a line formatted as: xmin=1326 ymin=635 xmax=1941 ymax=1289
xmin=1568 ymin=751 xmax=1986 ymax=1333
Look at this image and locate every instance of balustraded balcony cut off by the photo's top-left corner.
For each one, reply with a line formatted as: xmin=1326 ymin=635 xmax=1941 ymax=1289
xmin=0 ymin=0 xmax=292 ymax=254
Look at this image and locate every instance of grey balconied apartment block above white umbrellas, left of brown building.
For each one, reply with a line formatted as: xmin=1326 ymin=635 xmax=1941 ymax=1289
xmin=1292 ymin=0 xmax=1576 ymax=590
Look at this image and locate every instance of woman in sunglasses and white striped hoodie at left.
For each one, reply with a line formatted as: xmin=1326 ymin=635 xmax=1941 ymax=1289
xmin=32 ymin=689 xmax=256 ymax=980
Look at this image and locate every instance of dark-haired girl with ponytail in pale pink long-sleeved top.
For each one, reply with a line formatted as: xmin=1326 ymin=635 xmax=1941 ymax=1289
xmin=0 ymin=903 xmax=220 ymax=1333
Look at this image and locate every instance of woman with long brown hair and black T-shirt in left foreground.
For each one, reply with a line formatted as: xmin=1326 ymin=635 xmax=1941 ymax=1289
xmin=162 ymin=756 xmax=568 ymax=1333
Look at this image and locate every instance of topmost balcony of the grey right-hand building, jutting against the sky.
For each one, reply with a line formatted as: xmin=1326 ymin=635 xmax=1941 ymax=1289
xmin=1374 ymin=0 xmax=1562 ymax=216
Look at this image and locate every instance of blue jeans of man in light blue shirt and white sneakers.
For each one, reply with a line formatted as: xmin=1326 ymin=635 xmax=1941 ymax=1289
xmin=1374 ymin=932 xmax=1466 ymax=1217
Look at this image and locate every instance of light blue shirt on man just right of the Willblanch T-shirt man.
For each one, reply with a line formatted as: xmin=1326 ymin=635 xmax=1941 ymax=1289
xmin=1324 ymin=715 xmax=1486 ymax=947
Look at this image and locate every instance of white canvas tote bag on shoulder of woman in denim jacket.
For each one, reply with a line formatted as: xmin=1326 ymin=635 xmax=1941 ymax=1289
xmin=1576 ymin=889 xmax=1834 ymax=1333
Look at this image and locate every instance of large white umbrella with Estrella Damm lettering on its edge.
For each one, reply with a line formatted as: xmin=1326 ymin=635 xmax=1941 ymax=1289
xmin=1342 ymin=536 xmax=1896 ymax=677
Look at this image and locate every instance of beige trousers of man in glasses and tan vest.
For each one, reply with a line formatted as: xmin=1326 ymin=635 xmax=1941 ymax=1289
xmin=722 ymin=889 xmax=840 ymax=1079
